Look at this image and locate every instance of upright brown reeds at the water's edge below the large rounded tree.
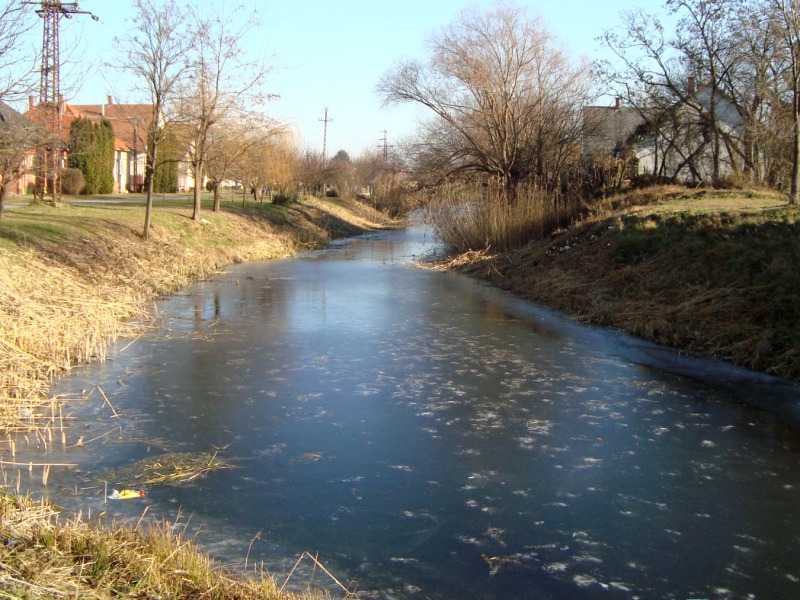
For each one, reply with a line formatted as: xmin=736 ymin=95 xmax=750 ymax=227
xmin=427 ymin=180 xmax=580 ymax=252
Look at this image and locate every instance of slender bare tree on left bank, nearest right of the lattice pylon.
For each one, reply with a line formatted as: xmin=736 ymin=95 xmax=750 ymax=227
xmin=121 ymin=0 xmax=189 ymax=239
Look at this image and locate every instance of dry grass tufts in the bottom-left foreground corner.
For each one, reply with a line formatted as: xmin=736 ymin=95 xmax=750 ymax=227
xmin=0 ymin=494 xmax=326 ymax=600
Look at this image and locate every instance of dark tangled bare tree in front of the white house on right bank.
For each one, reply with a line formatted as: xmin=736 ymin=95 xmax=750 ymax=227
xmin=597 ymin=0 xmax=730 ymax=183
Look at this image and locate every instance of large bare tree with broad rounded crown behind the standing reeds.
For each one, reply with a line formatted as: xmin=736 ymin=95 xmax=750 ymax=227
xmin=378 ymin=5 xmax=591 ymax=200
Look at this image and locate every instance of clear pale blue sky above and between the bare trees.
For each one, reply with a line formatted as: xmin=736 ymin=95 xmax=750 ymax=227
xmin=45 ymin=0 xmax=657 ymax=157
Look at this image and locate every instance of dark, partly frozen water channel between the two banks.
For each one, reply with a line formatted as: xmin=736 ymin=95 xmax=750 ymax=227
xmin=33 ymin=221 xmax=800 ymax=599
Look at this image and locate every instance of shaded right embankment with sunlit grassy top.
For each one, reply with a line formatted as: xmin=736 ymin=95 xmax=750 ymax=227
xmin=444 ymin=187 xmax=800 ymax=381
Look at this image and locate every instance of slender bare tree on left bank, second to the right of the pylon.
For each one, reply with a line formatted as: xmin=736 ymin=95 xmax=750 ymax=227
xmin=181 ymin=3 xmax=269 ymax=220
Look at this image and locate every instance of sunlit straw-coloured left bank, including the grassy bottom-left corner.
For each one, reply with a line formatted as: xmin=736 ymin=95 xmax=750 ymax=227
xmin=0 ymin=193 xmax=387 ymax=598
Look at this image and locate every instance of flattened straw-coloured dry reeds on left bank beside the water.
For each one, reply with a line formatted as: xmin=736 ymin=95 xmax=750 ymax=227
xmin=0 ymin=251 xmax=143 ymax=431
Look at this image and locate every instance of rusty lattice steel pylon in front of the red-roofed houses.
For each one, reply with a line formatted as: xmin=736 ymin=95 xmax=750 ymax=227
xmin=23 ymin=0 xmax=100 ymax=204
